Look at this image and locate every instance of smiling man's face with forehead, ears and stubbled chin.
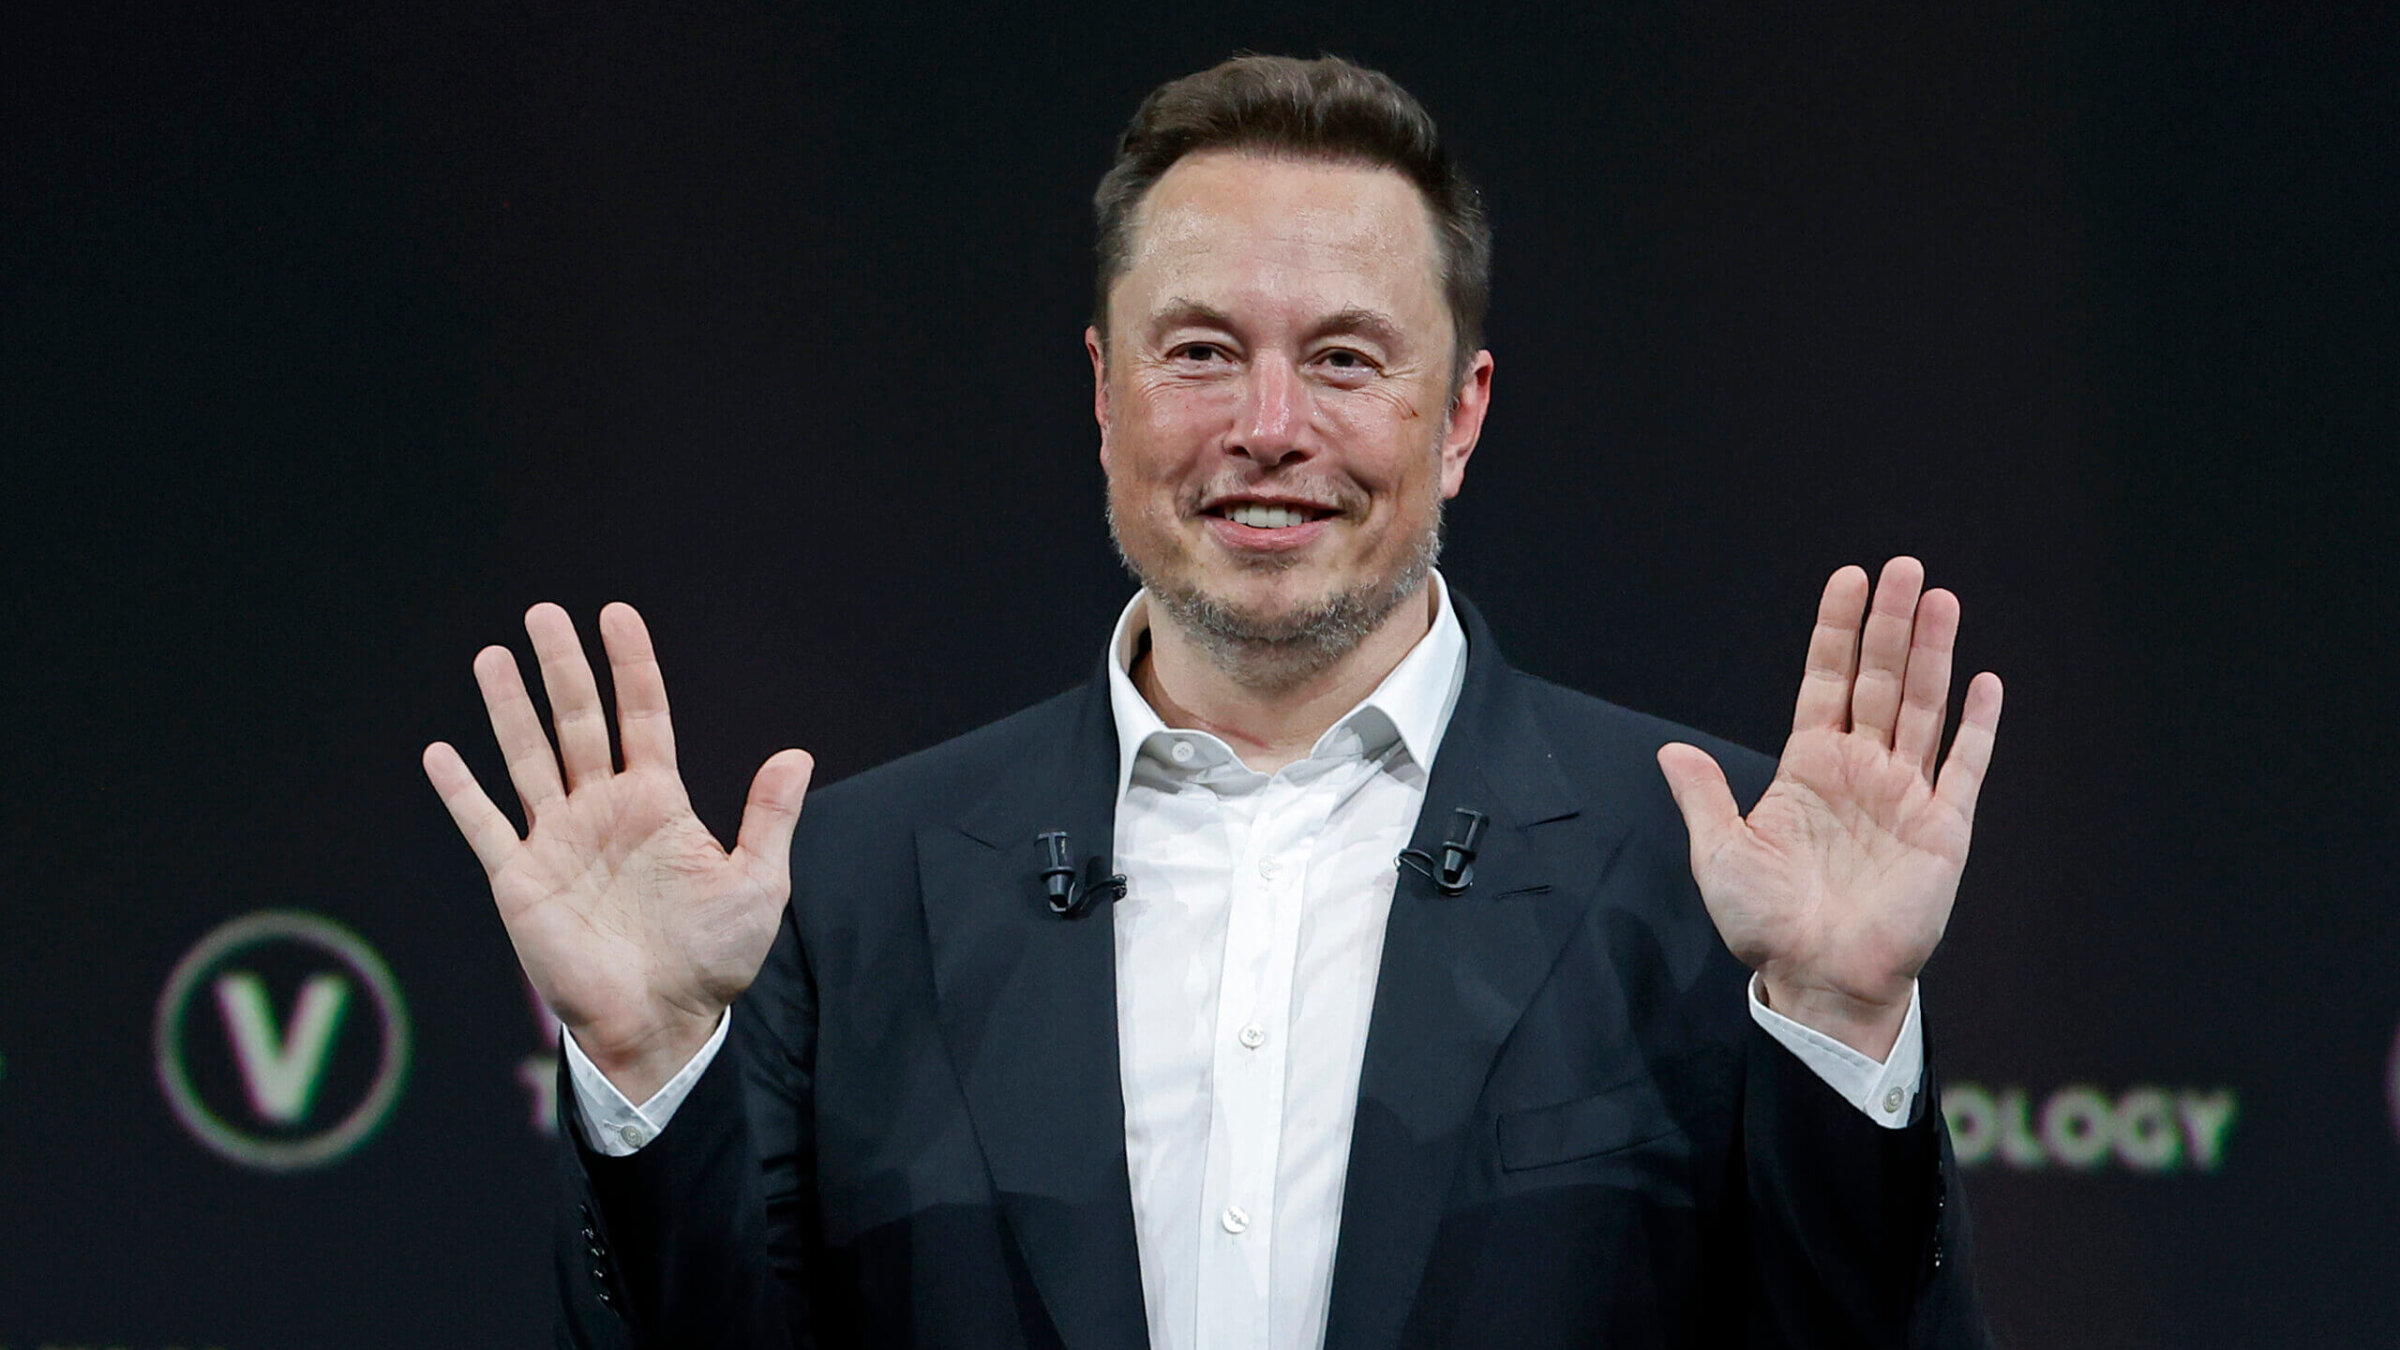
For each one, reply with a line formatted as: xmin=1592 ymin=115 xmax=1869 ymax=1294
xmin=1085 ymin=151 xmax=1490 ymax=658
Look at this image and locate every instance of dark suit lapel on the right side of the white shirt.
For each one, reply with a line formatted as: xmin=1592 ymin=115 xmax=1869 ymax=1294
xmin=1325 ymin=591 xmax=1622 ymax=1350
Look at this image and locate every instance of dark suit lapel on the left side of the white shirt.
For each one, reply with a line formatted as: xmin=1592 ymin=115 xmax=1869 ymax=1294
xmin=917 ymin=682 xmax=1147 ymax=1350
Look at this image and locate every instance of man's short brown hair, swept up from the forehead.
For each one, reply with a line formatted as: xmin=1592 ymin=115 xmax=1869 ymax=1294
xmin=1092 ymin=55 xmax=1493 ymax=375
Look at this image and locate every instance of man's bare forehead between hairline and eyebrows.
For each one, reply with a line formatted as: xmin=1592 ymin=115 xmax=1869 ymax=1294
xmin=1111 ymin=151 xmax=1447 ymax=324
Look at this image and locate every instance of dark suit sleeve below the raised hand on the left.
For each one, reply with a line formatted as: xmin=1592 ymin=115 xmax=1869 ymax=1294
xmin=557 ymin=910 xmax=818 ymax=1350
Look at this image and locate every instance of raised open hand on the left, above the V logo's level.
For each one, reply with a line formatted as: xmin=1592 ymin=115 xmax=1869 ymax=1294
xmin=425 ymin=603 xmax=816 ymax=1103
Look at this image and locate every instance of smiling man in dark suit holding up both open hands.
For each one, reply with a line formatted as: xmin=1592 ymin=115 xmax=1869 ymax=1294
xmin=425 ymin=58 xmax=1999 ymax=1348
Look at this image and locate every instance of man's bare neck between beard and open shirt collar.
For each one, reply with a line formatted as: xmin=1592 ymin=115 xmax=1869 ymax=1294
xmin=1133 ymin=581 xmax=1435 ymax=773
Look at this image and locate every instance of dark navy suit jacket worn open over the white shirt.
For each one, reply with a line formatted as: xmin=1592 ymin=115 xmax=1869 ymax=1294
xmin=559 ymin=593 xmax=1985 ymax=1350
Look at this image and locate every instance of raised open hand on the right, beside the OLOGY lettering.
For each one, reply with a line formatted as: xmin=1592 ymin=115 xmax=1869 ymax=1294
xmin=1658 ymin=557 xmax=1999 ymax=1059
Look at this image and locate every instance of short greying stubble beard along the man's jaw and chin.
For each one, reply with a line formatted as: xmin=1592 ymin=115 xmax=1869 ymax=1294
xmin=1109 ymin=485 xmax=1442 ymax=692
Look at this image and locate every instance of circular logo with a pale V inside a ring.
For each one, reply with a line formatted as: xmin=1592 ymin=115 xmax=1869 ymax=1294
xmin=154 ymin=910 xmax=408 ymax=1172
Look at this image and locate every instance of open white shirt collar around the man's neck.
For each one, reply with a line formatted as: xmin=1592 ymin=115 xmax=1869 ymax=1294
xmin=1109 ymin=569 xmax=1466 ymax=802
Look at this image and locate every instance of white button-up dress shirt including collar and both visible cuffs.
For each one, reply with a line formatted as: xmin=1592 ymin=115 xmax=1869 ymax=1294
xmin=566 ymin=574 xmax=1922 ymax=1350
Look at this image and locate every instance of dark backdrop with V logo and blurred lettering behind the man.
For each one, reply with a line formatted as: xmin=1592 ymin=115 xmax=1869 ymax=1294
xmin=0 ymin=2 xmax=2400 ymax=1350
